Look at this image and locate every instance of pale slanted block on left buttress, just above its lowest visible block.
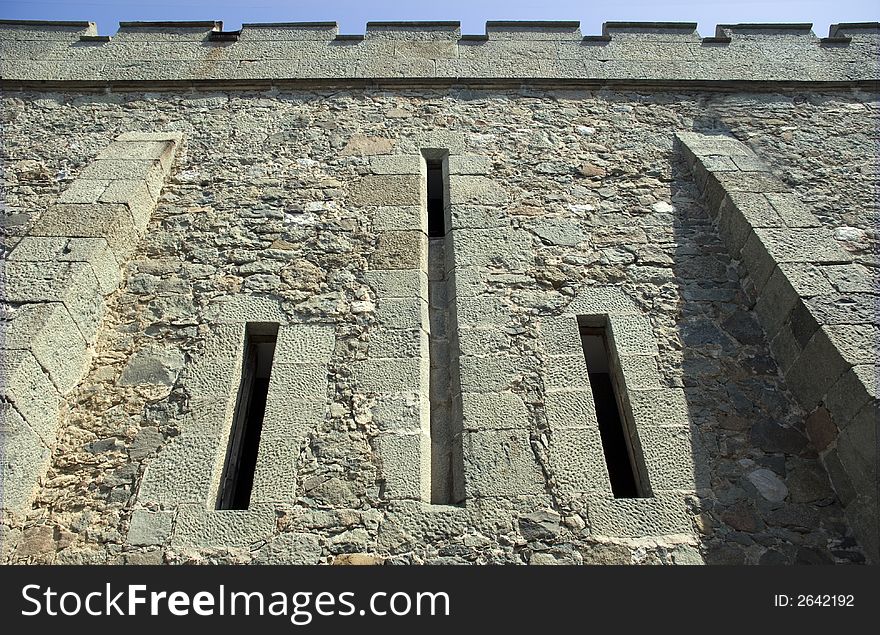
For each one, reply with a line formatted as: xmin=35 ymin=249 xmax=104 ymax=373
xmin=0 ymin=350 xmax=60 ymax=447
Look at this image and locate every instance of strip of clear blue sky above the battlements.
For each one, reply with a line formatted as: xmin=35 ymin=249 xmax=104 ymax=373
xmin=0 ymin=0 xmax=880 ymax=36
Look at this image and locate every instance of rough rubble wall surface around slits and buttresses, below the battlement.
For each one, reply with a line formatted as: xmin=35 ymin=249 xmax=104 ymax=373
xmin=2 ymin=82 xmax=878 ymax=564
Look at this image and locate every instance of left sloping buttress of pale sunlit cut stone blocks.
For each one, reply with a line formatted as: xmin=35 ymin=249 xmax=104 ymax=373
xmin=0 ymin=132 xmax=182 ymax=513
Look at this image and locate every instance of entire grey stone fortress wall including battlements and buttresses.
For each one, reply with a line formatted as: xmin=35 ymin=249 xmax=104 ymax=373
xmin=0 ymin=21 xmax=880 ymax=564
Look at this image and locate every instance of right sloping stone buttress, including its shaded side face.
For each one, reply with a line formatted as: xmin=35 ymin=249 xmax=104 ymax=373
xmin=677 ymin=132 xmax=880 ymax=562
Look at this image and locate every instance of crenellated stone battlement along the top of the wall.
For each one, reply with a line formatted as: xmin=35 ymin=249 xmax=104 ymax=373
xmin=0 ymin=20 xmax=880 ymax=88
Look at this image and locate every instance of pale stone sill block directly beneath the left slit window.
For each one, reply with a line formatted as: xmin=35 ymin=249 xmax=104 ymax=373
xmin=171 ymin=503 xmax=275 ymax=549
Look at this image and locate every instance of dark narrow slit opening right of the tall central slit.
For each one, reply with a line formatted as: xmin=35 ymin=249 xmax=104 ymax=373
xmin=580 ymin=323 xmax=644 ymax=498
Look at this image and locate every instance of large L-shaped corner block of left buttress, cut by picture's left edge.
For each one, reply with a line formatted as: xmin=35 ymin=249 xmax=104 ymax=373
xmin=0 ymin=261 xmax=104 ymax=344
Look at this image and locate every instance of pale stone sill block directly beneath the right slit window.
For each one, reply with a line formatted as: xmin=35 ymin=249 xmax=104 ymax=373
xmin=587 ymin=493 xmax=693 ymax=538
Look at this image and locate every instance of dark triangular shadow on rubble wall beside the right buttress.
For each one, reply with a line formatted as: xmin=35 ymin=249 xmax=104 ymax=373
xmin=661 ymin=137 xmax=864 ymax=564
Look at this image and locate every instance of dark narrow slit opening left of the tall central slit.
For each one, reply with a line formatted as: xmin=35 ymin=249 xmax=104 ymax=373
xmin=217 ymin=323 xmax=278 ymax=509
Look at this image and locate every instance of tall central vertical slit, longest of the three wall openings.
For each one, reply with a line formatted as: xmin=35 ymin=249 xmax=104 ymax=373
xmin=423 ymin=150 xmax=464 ymax=505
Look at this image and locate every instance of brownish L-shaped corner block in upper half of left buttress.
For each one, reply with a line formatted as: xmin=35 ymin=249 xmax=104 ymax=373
xmin=31 ymin=203 xmax=139 ymax=266
